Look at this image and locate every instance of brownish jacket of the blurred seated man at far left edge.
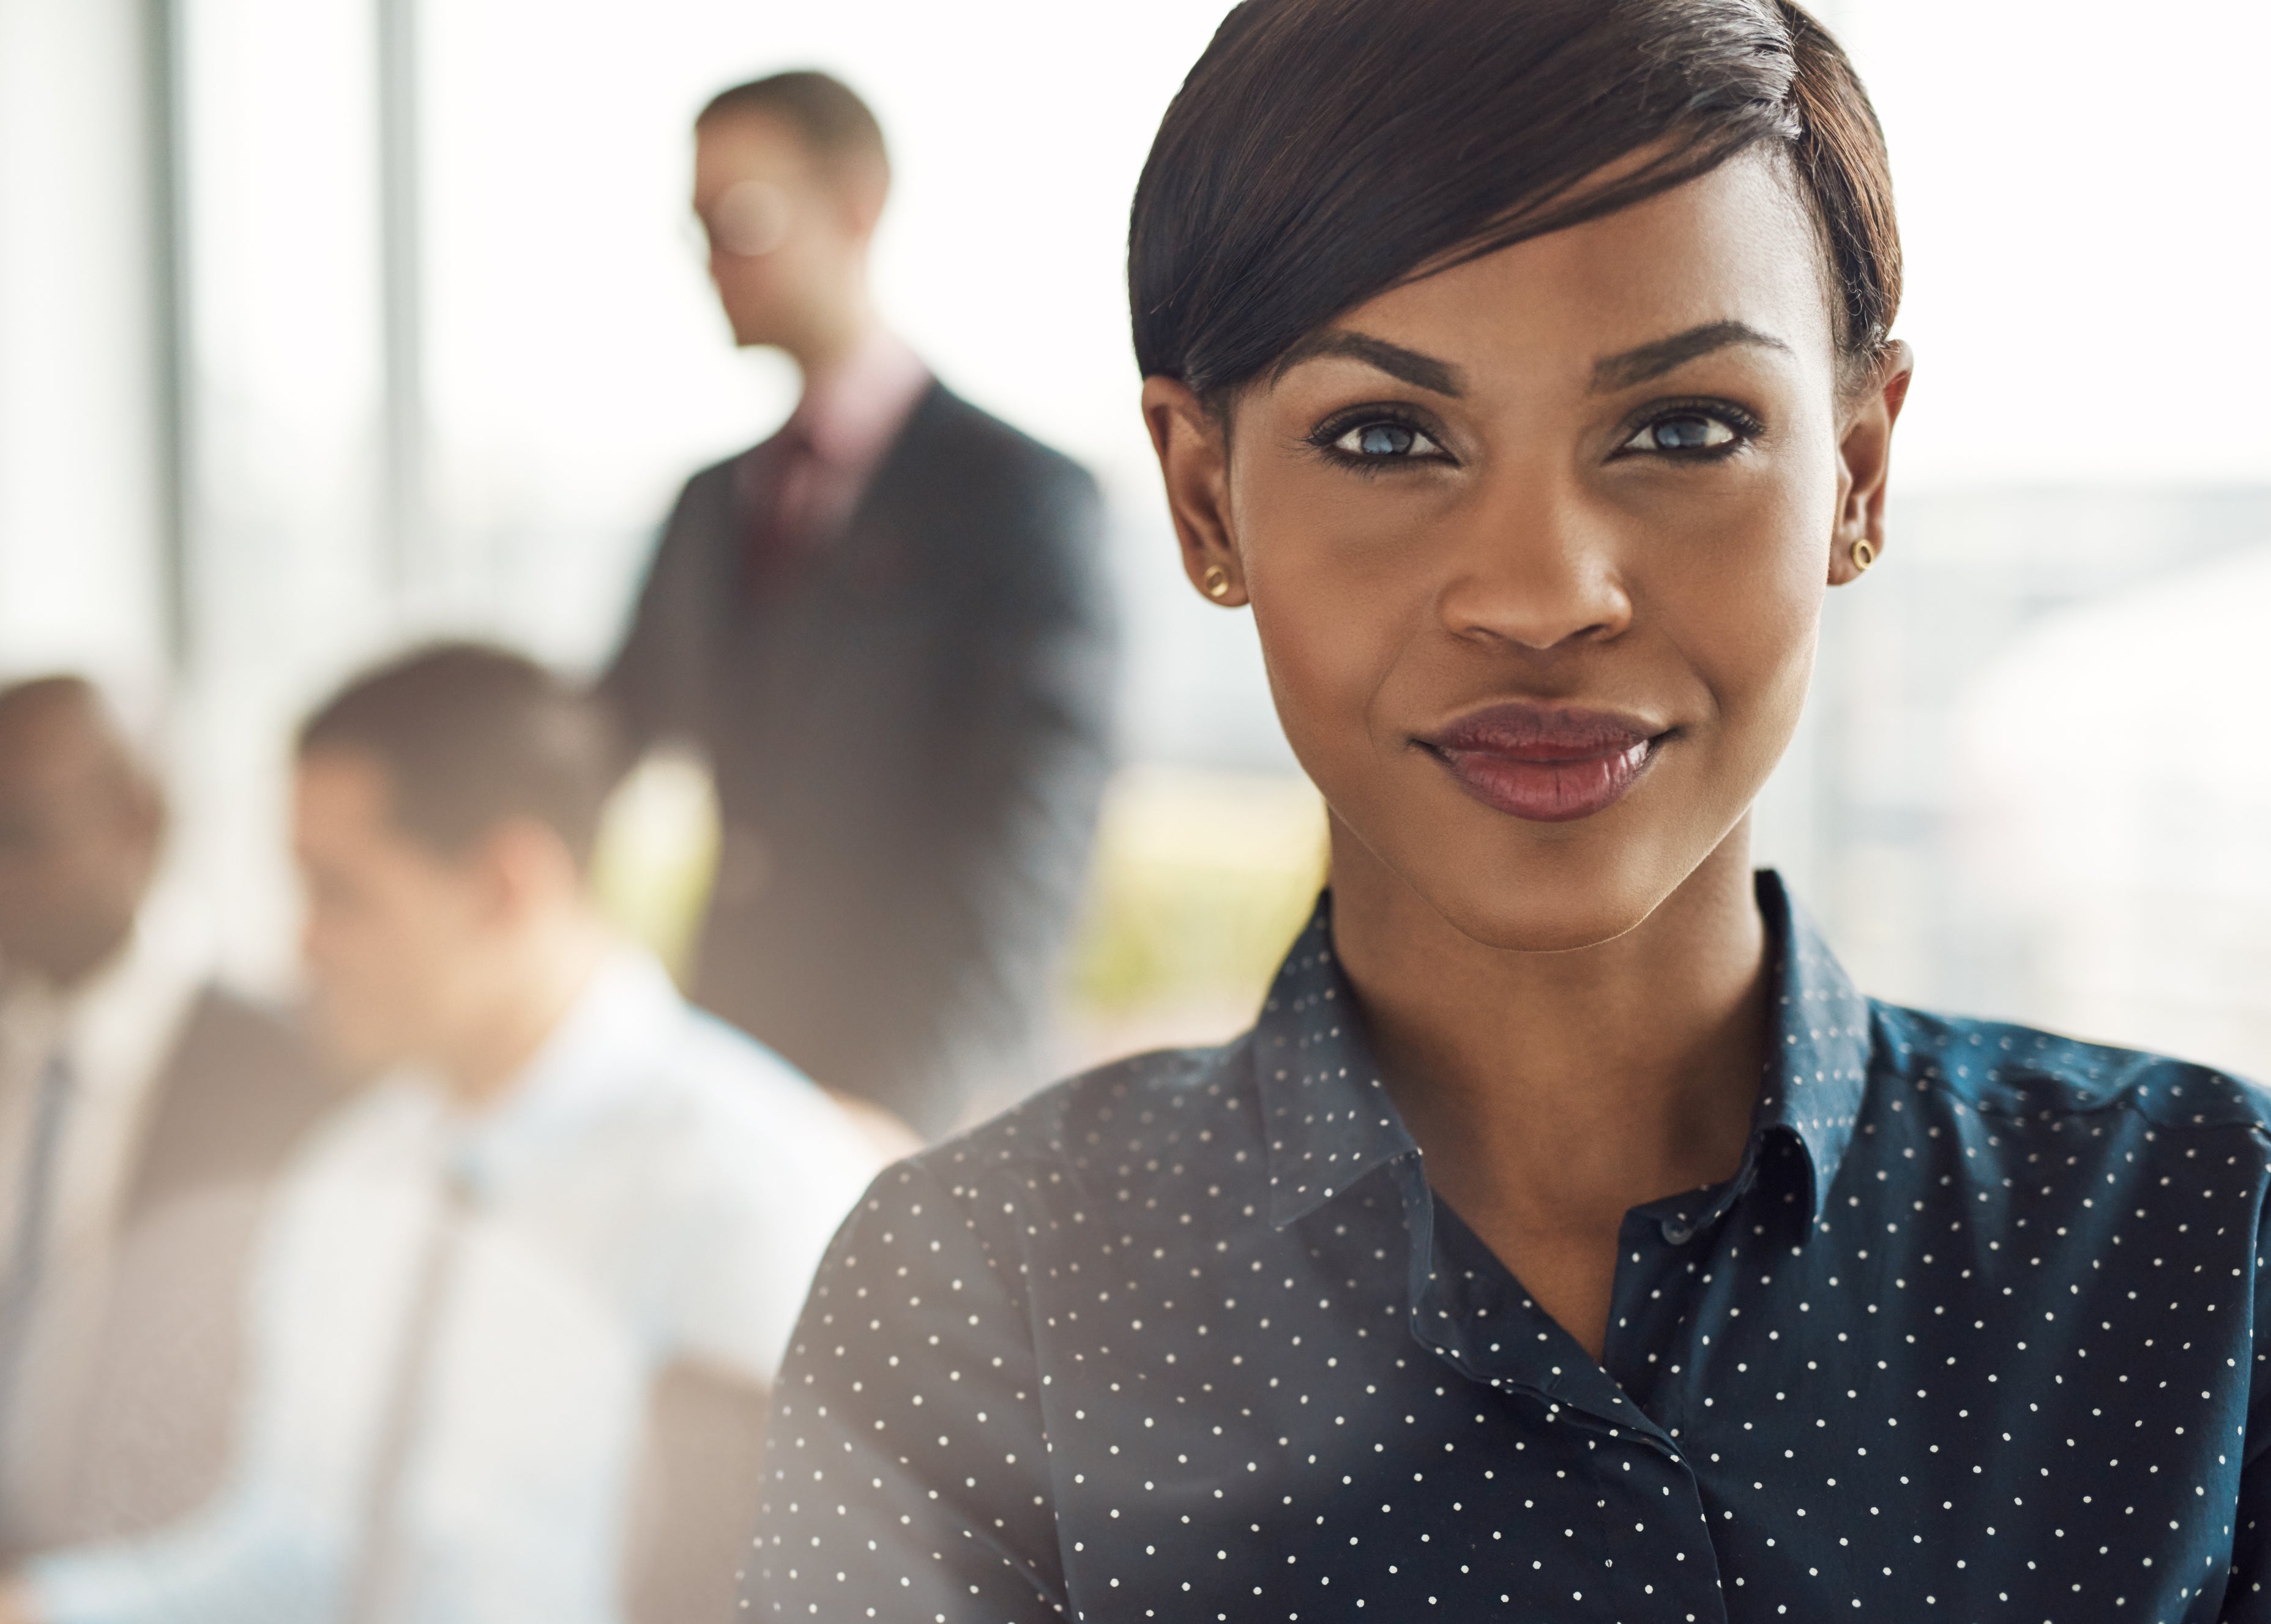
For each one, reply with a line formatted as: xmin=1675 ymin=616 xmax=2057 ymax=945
xmin=39 ymin=988 xmax=343 ymax=1544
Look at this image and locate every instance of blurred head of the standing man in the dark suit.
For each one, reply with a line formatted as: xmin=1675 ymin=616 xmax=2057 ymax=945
xmin=695 ymin=73 xmax=890 ymax=366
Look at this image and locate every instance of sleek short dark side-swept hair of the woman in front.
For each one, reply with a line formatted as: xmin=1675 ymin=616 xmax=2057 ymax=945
xmin=1128 ymin=0 xmax=1901 ymax=398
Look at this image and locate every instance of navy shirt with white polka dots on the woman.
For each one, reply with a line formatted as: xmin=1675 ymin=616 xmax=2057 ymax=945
xmin=745 ymin=874 xmax=2271 ymax=1624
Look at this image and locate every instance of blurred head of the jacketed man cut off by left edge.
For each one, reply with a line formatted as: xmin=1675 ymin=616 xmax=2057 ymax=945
xmin=0 ymin=677 xmax=166 ymax=986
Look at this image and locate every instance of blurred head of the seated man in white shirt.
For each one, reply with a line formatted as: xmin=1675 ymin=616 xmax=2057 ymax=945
xmin=293 ymin=645 xmax=620 ymax=1084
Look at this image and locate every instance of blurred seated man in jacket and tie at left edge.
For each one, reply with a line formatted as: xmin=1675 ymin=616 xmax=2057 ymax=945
xmin=0 ymin=677 xmax=336 ymax=1556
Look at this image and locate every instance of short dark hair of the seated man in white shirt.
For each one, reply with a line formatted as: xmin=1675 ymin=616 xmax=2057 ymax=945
xmin=300 ymin=643 xmax=625 ymax=868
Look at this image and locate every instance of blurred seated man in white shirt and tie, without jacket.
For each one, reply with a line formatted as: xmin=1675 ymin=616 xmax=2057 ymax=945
xmin=0 ymin=645 xmax=876 ymax=1624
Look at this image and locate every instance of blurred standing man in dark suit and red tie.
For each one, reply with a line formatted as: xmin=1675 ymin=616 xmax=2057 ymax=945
xmin=606 ymin=73 xmax=1113 ymax=1133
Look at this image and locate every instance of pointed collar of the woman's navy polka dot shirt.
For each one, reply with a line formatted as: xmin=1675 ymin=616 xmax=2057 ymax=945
xmin=1249 ymin=870 xmax=1869 ymax=1229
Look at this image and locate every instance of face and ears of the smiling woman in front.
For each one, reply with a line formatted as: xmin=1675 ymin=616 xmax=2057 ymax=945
xmin=1144 ymin=157 xmax=1907 ymax=950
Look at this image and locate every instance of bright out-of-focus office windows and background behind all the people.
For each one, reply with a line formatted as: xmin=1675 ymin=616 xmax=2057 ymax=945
xmin=0 ymin=0 xmax=2271 ymax=1075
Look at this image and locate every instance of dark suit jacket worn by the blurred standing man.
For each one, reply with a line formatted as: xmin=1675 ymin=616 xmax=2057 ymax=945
xmin=604 ymin=384 xmax=1115 ymax=1133
